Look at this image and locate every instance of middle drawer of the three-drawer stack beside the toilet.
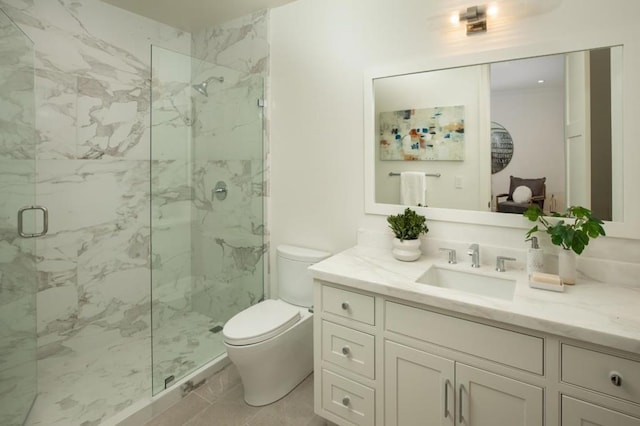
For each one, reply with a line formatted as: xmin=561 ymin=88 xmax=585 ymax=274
xmin=322 ymin=321 xmax=375 ymax=379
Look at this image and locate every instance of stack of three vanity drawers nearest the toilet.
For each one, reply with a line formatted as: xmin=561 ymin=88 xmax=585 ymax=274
xmin=313 ymin=281 xmax=382 ymax=426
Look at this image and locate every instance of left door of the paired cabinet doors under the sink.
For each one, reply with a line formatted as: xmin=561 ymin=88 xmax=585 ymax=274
xmin=384 ymin=341 xmax=456 ymax=426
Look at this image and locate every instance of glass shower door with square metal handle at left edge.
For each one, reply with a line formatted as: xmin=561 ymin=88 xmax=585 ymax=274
xmin=0 ymin=9 xmax=37 ymax=426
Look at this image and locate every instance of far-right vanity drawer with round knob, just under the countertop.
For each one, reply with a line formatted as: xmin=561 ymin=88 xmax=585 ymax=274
xmin=562 ymin=344 xmax=640 ymax=403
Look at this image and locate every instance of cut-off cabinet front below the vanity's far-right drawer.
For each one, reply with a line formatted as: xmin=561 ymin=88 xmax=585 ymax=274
xmin=562 ymin=395 xmax=640 ymax=426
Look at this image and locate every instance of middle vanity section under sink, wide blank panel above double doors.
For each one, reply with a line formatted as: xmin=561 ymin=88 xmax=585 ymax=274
xmin=384 ymin=301 xmax=544 ymax=426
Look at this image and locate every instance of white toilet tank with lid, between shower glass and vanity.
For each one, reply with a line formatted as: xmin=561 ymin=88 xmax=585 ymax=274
xmin=276 ymin=245 xmax=331 ymax=308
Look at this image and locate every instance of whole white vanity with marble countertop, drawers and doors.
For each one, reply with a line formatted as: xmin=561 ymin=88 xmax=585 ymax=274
xmin=310 ymin=246 xmax=640 ymax=426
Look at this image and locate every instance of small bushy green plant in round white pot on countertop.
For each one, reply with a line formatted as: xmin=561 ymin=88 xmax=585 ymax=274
xmin=387 ymin=207 xmax=429 ymax=262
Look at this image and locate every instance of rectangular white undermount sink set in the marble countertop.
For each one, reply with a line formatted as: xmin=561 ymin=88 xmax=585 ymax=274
xmin=416 ymin=265 xmax=516 ymax=300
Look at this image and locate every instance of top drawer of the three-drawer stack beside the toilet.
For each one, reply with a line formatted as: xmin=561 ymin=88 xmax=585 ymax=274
xmin=322 ymin=285 xmax=375 ymax=325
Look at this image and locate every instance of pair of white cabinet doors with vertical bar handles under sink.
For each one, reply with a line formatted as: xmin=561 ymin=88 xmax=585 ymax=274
xmin=384 ymin=341 xmax=543 ymax=426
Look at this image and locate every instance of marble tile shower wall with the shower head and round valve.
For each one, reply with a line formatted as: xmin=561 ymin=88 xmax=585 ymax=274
xmin=191 ymin=11 xmax=269 ymax=323
